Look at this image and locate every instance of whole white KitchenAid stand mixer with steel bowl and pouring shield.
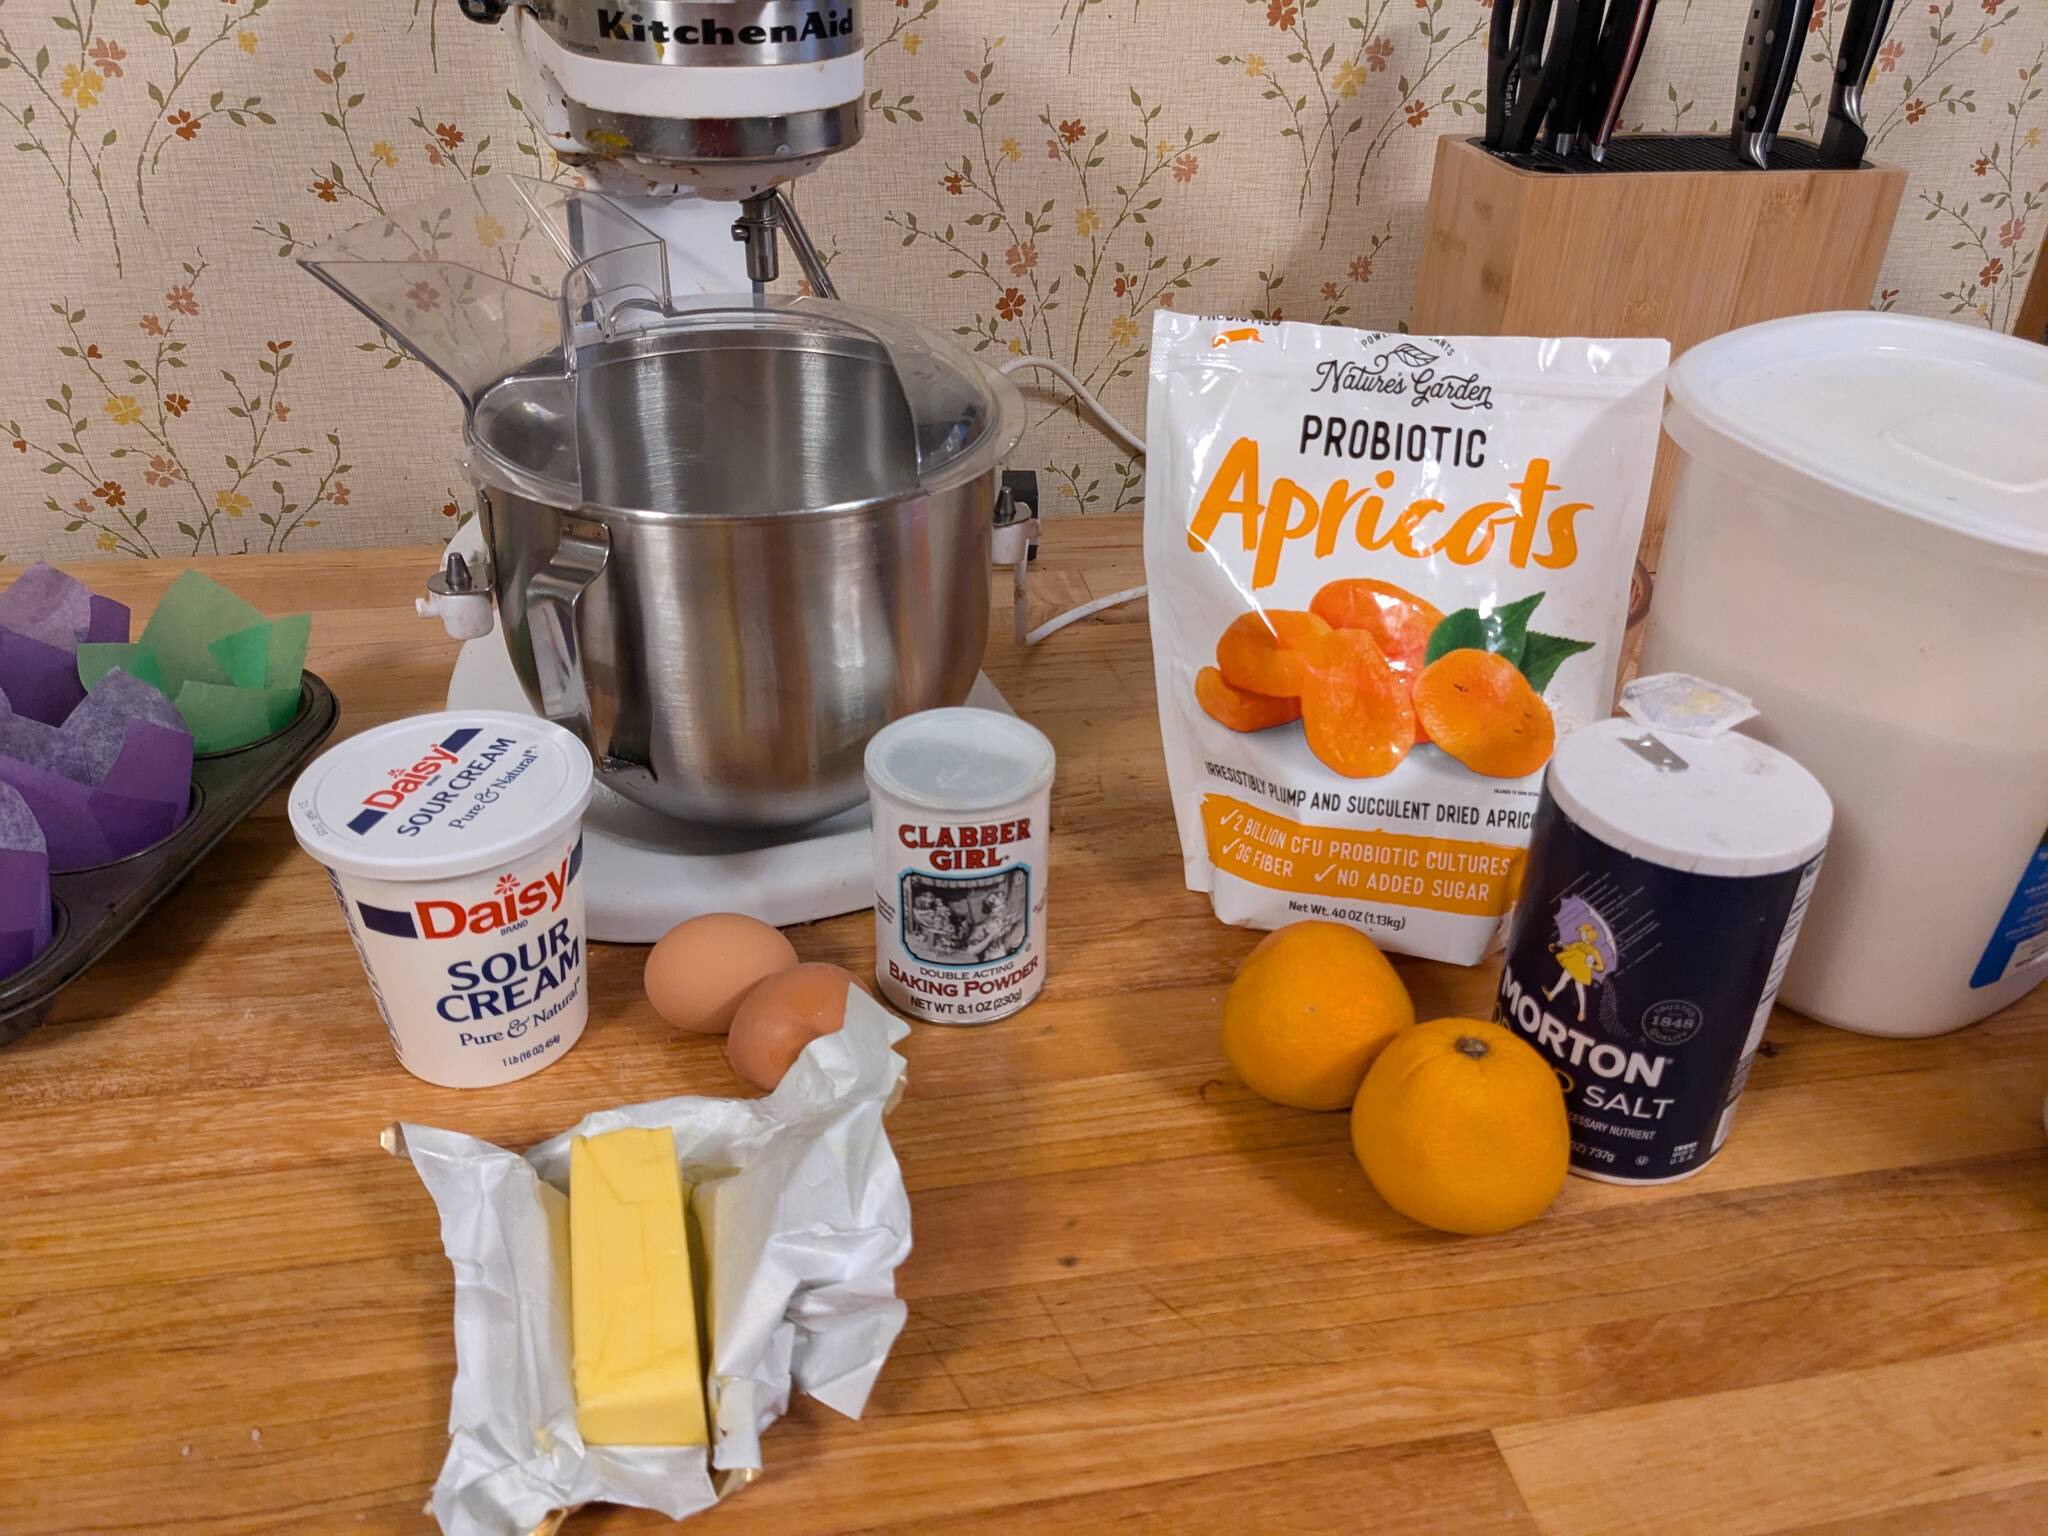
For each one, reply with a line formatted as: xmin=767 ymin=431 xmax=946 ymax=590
xmin=303 ymin=0 xmax=1028 ymax=942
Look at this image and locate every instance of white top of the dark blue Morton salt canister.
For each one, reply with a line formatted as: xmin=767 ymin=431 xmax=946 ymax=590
xmin=1544 ymin=719 xmax=1835 ymax=874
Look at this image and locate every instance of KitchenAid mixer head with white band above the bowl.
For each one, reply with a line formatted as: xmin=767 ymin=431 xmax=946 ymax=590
xmin=459 ymin=0 xmax=864 ymax=293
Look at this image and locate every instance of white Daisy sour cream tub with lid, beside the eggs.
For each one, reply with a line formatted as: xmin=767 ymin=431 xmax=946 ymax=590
xmin=291 ymin=711 xmax=592 ymax=1087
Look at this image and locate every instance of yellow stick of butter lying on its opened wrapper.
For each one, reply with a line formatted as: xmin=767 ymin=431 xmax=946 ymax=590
xmin=569 ymin=1126 xmax=707 ymax=1446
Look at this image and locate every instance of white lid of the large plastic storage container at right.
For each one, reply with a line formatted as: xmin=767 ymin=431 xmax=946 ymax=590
xmin=1665 ymin=311 xmax=2048 ymax=555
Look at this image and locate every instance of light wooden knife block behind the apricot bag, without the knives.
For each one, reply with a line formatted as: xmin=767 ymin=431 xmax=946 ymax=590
xmin=1409 ymin=137 xmax=1907 ymax=569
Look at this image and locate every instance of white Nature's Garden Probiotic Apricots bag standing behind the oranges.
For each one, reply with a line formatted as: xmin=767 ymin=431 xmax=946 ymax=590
xmin=1145 ymin=311 xmax=1669 ymax=965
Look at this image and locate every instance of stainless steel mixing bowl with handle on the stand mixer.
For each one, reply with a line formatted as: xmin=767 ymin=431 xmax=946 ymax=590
xmin=467 ymin=301 xmax=1022 ymax=827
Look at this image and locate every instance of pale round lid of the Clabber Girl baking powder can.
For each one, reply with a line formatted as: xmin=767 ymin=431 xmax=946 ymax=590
xmin=866 ymin=709 xmax=1053 ymax=813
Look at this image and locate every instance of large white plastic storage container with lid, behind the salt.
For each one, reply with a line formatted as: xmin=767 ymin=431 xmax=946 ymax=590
xmin=1642 ymin=313 xmax=2048 ymax=1036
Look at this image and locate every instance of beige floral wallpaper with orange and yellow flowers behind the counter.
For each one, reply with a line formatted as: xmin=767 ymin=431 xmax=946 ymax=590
xmin=0 ymin=0 xmax=2048 ymax=559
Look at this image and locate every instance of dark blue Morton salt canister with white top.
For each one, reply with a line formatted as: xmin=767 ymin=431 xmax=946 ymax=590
xmin=1499 ymin=719 xmax=1829 ymax=1184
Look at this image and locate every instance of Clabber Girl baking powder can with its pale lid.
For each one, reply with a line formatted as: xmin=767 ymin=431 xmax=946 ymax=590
xmin=866 ymin=709 xmax=1053 ymax=1024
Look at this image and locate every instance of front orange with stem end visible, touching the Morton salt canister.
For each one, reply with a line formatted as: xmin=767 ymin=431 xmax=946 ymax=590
xmin=1352 ymin=1018 xmax=1571 ymax=1233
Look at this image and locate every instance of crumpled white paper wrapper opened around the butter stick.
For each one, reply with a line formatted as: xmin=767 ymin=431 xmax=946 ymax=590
xmin=387 ymin=987 xmax=909 ymax=1536
